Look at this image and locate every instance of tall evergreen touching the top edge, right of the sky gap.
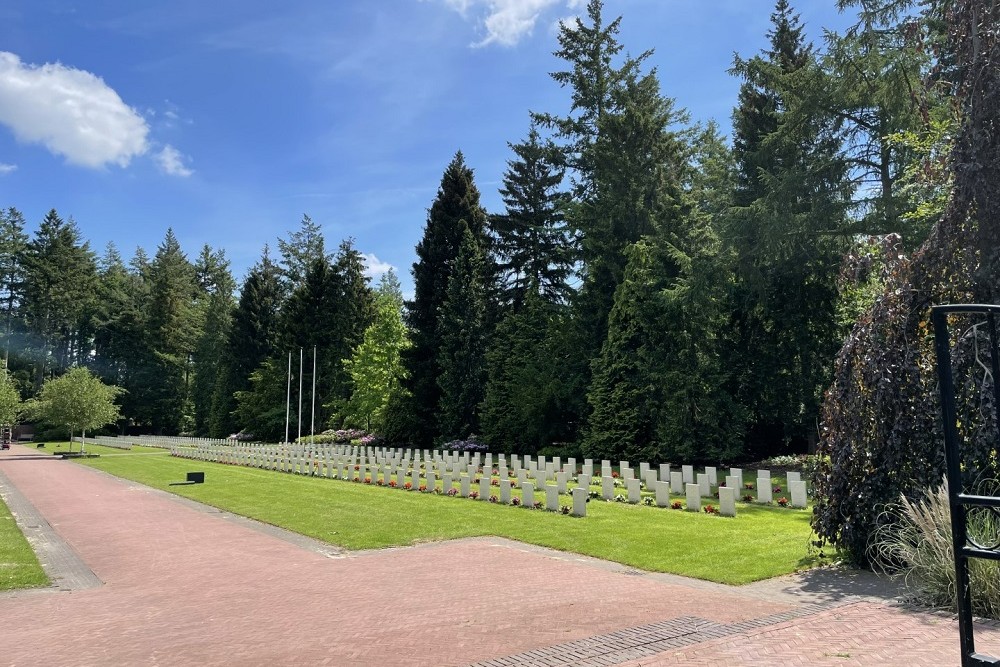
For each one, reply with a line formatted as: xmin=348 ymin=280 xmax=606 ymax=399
xmin=724 ymin=0 xmax=846 ymax=455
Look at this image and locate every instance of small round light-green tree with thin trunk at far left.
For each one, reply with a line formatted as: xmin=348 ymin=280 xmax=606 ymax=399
xmin=25 ymin=367 xmax=123 ymax=451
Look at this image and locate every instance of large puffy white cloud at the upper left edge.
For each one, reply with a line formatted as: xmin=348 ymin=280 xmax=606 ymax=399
xmin=0 ymin=51 xmax=149 ymax=169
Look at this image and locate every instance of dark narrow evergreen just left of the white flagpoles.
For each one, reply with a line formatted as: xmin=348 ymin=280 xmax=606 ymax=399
xmin=209 ymin=246 xmax=282 ymax=437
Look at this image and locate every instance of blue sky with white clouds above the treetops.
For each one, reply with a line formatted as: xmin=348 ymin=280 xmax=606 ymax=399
xmin=0 ymin=0 xmax=850 ymax=291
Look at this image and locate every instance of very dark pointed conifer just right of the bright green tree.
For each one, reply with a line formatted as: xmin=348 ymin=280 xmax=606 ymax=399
xmin=400 ymin=152 xmax=486 ymax=446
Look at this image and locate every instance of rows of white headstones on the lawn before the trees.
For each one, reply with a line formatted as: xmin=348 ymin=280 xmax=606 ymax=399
xmin=171 ymin=444 xmax=807 ymax=516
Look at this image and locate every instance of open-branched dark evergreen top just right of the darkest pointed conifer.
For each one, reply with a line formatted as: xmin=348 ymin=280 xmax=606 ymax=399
xmin=490 ymin=124 xmax=575 ymax=308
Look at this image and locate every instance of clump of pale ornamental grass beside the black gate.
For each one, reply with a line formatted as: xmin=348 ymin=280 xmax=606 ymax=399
xmin=871 ymin=482 xmax=1000 ymax=618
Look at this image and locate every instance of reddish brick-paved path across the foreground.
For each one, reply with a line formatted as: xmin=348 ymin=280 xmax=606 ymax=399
xmin=0 ymin=447 xmax=1000 ymax=667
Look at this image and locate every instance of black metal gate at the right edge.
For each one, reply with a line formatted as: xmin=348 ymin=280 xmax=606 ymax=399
xmin=931 ymin=304 xmax=1000 ymax=667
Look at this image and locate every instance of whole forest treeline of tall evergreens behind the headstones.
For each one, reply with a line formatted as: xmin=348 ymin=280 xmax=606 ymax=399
xmin=0 ymin=0 xmax=958 ymax=462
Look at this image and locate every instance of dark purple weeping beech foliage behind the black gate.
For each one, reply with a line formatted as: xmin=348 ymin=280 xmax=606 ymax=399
xmin=813 ymin=0 xmax=1000 ymax=563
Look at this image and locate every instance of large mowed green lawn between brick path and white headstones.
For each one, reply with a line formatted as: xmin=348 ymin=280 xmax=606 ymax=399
xmin=58 ymin=446 xmax=819 ymax=584
